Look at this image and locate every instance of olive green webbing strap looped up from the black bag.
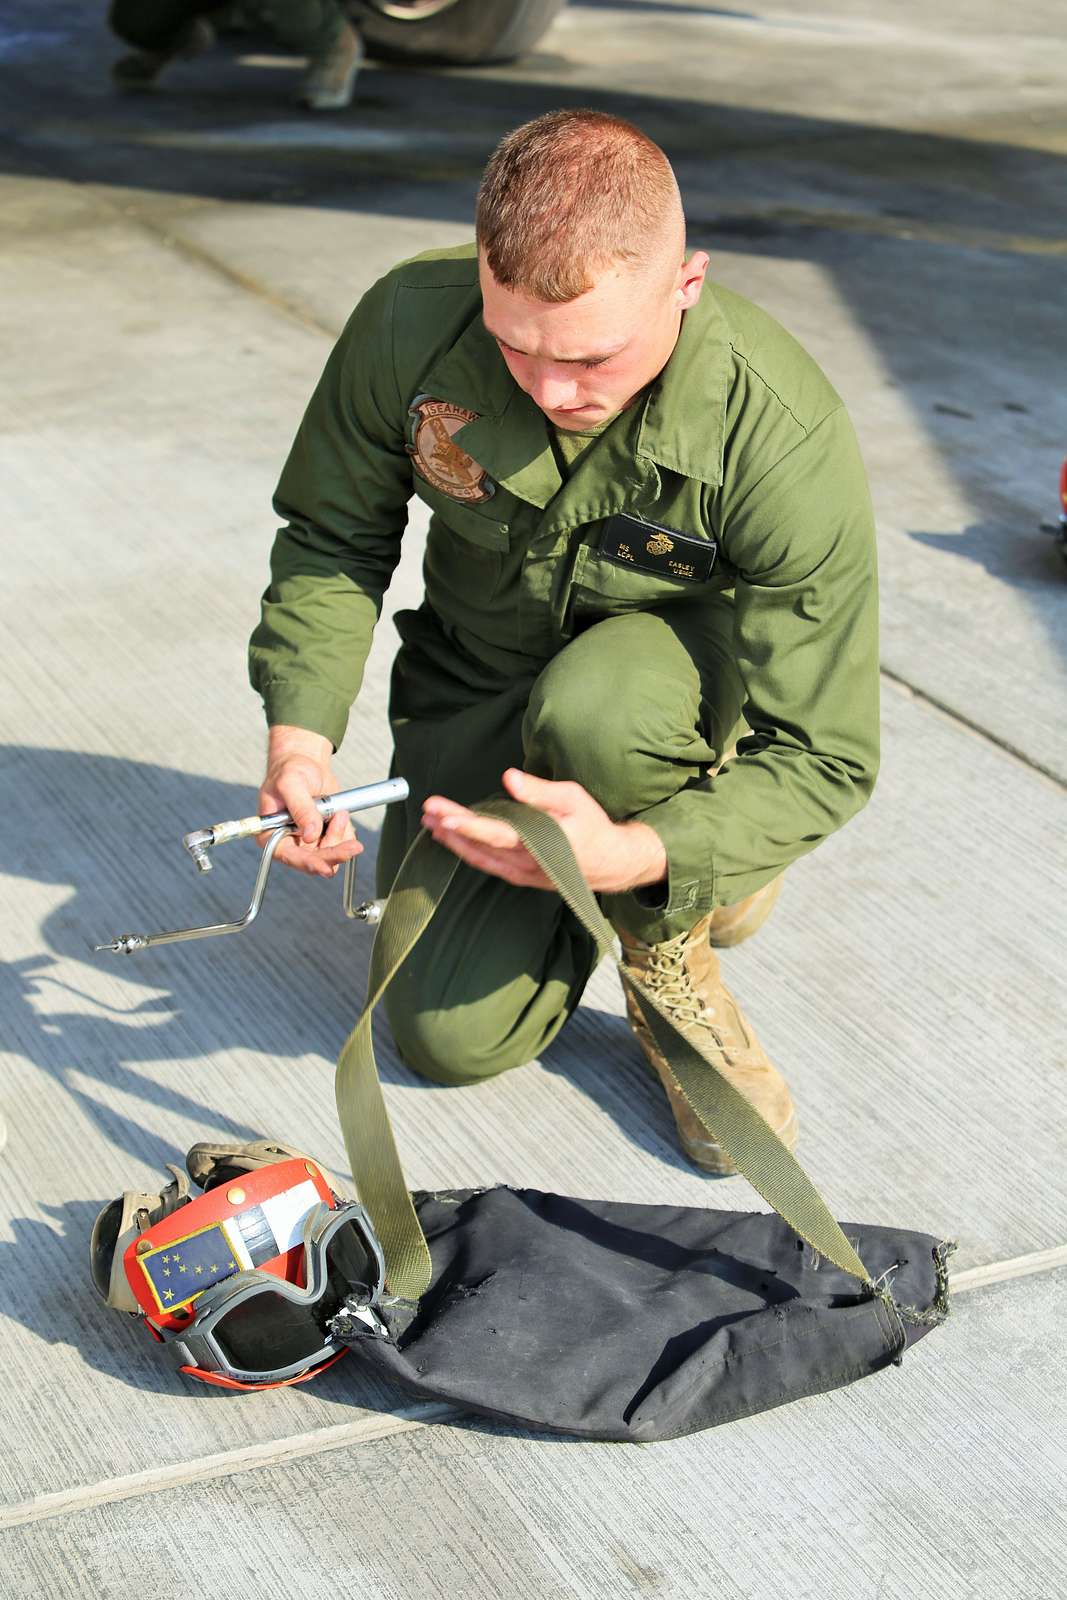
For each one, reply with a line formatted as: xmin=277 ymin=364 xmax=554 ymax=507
xmin=338 ymin=800 xmax=870 ymax=1299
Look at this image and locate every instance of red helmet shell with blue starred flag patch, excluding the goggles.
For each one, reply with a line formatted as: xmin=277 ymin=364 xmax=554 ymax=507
xmin=123 ymin=1160 xmax=334 ymax=1333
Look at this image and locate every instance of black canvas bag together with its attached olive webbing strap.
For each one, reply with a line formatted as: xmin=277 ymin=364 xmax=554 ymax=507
xmin=331 ymin=800 xmax=952 ymax=1442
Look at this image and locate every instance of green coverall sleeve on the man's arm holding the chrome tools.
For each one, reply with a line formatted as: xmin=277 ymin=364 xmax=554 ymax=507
xmin=250 ymin=280 xmax=411 ymax=747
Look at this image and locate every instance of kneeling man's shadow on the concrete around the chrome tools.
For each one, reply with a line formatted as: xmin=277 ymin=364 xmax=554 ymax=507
xmin=0 ymin=747 xmax=685 ymax=1179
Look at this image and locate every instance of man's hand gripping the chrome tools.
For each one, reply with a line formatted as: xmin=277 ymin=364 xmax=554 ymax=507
xmin=258 ymin=725 xmax=363 ymax=878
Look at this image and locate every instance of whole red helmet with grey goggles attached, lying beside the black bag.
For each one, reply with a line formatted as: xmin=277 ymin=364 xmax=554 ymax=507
xmin=91 ymin=1141 xmax=389 ymax=1389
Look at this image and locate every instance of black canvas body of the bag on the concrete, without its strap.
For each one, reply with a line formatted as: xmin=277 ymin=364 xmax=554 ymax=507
xmin=334 ymin=1189 xmax=945 ymax=1443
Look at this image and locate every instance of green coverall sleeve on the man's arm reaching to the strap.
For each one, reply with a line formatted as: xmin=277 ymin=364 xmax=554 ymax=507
xmin=641 ymin=408 xmax=878 ymax=914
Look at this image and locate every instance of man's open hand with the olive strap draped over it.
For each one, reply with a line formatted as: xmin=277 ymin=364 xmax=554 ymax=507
xmin=422 ymin=766 xmax=667 ymax=894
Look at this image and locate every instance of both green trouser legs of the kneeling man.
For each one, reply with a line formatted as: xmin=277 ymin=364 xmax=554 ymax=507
xmin=378 ymin=597 xmax=742 ymax=1083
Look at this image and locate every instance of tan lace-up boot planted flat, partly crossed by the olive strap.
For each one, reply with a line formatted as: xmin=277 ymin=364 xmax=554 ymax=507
xmin=619 ymin=917 xmax=797 ymax=1174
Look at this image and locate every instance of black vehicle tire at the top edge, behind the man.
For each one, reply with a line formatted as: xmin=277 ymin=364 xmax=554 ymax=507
xmin=350 ymin=0 xmax=565 ymax=66
